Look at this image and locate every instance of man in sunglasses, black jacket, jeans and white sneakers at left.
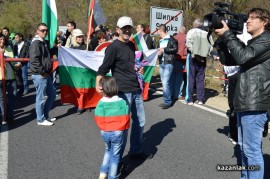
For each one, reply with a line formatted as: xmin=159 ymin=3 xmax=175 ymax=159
xmin=29 ymin=23 xmax=56 ymax=126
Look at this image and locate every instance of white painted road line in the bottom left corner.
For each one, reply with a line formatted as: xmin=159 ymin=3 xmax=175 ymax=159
xmin=0 ymin=124 xmax=8 ymax=179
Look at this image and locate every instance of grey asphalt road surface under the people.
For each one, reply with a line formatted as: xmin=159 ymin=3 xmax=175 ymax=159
xmin=0 ymin=83 xmax=270 ymax=179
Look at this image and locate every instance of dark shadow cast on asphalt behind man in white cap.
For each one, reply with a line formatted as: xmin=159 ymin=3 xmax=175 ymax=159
xmin=120 ymin=118 xmax=176 ymax=179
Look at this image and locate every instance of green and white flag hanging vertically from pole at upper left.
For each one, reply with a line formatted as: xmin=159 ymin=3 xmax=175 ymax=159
xmin=42 ymin=0 xmax=58 ymax=48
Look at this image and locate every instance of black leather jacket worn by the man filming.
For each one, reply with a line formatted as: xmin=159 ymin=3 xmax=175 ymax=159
xmin=224 ymin=31 xmax=270 ymax=112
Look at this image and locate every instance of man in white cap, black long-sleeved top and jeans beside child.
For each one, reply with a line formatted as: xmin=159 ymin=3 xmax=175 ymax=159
xmin=96 ymin=16 xmax=153 ymax=178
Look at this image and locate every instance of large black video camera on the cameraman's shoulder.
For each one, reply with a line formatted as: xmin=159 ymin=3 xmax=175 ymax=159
xmin=203 ymin=2 xmax=248 ymax=34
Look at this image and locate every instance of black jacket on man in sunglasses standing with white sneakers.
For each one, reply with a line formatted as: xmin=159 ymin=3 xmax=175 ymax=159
xmin=29 ymin=37 xmax=52 ymax=75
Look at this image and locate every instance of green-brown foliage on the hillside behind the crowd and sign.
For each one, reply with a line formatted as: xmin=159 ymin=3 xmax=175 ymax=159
xmin=0 ymin=0 xmax=270 ymax=34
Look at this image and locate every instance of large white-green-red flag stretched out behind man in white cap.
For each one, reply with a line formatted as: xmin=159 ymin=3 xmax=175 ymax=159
xmin=58 ymin=47 xmax=157 ymax=109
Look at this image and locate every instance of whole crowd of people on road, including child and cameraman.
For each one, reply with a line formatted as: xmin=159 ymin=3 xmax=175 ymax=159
xmin=0 ymin=8 xmax=270 ymax=179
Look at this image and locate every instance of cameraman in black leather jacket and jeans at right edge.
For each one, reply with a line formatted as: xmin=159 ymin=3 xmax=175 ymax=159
xmin=215 ymin=8 xmax=270 ymax=179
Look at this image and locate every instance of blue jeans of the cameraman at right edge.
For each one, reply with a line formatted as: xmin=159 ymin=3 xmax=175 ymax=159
xmin=237 ymin=111 xmax=267 ymax=179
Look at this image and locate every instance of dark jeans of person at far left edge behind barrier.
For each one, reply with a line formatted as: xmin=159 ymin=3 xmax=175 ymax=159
xmin=0 ymin=80 xmax=17 ymax=121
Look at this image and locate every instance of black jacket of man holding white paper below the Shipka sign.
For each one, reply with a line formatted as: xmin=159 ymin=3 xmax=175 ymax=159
xmin=158 ymin=36 xmax=178 ymax=64
